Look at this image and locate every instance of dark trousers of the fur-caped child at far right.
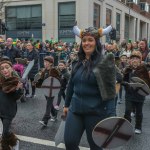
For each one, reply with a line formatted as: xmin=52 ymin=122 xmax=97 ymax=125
xmin=124 ymin=100 xmax=144 ymax=130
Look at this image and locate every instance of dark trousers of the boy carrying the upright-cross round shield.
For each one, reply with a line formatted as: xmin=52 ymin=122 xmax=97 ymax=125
xmin=42 ymin=96 xmax=57 ymax=123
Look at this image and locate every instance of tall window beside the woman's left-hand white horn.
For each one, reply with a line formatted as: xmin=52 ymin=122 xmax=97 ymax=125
xmin=58 ymin=2 xmax=76 ymax=42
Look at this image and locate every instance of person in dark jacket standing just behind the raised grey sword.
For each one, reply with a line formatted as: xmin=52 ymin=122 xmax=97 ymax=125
xmin=26 ymin=42 xmax=39 ymax=98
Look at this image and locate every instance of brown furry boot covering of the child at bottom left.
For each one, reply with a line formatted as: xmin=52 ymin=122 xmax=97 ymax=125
xmin=1 ymin=133 xmax=18 ymax=150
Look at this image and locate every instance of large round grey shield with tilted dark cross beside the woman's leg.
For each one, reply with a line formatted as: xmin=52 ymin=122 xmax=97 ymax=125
xmin=92 ymin=117 xmax=134 ymax=149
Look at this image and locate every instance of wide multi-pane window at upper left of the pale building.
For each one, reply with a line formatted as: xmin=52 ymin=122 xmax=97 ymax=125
xmin=6 ymin=5 xmax=42 ymax=30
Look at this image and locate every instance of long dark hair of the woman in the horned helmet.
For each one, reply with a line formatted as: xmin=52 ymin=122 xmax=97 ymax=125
xmin=72 ymin=39 xmax=102 ymax=77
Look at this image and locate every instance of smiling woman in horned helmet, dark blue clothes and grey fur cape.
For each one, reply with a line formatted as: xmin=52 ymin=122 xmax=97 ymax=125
xmin=63 ymin=23 xmax=116 ymax=150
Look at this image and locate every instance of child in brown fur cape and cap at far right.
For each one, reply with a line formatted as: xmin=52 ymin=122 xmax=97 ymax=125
xmin=123 ymin=51 xmax=150 ymax=134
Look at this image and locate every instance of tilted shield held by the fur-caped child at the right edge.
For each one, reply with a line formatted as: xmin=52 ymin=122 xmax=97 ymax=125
xmin=130 ymin=77 xmax=150 ymax=96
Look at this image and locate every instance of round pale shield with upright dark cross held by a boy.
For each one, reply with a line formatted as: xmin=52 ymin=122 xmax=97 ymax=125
xmin=41 ymin=77 xmax=61 ymax=97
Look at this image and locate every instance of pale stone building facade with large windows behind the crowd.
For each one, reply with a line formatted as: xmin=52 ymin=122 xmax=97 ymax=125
xmin=4 ymin=0 xmax=150 ymax=42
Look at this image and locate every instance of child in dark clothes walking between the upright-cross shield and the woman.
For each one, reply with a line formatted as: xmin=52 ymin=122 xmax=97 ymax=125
xmin=55 ymin=60 xmax=70 ymax=110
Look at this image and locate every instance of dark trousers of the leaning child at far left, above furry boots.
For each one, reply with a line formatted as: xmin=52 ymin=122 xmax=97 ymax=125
xmin=0 ymin=117 xmax=12 ymax=136
